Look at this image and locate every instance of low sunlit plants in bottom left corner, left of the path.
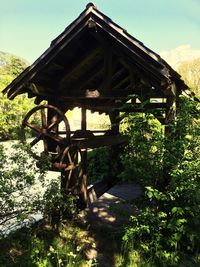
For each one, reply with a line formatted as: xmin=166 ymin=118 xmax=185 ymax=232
xmin=0 ymin=224 xmax=96 ymax=267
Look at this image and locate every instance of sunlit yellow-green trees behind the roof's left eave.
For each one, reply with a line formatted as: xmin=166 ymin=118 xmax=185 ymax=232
xmin=0 ymin=52 xmax=34 ymax=141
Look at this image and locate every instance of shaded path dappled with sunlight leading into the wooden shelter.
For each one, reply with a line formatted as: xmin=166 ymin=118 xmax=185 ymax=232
xmin=79 ymin=183 xmax=142 ymax=267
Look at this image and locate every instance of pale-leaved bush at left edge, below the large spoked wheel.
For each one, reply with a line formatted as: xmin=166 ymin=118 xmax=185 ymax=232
xmin=0 ymin=143 xmax=79 ymax=236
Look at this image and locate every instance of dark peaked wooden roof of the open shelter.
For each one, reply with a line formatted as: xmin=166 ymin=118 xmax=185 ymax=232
xmin=3 ymin=3 xmax=187 ymax=113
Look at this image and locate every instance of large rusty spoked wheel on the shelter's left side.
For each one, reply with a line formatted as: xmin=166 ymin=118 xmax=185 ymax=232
xmin=22 ymin=105 xmax=70 ymax=161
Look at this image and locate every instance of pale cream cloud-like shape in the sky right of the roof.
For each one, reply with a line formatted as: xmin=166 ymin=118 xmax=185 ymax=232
xmin=160 ymin=45 xmax=200 ymax=70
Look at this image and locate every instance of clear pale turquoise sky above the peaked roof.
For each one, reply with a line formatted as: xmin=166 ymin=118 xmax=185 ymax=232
xmin=0 ymin=0 xmax=200 ymax=63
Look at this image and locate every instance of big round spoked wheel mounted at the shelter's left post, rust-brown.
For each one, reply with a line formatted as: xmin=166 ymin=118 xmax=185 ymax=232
xmin=22 ymin=105 xmax=70 ymax=159
